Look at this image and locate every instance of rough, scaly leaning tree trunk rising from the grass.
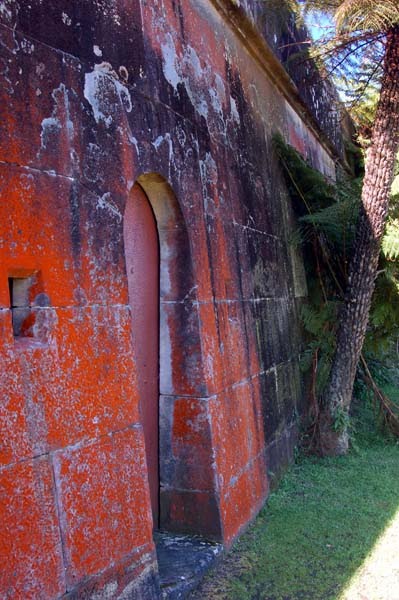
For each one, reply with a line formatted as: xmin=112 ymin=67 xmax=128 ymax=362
xmin=320 ymin=26 xmax=399 ymax=455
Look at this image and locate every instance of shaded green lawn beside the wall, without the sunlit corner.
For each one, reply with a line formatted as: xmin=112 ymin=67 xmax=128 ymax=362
xmin=194 ymin=426 xmax=399 ymax=600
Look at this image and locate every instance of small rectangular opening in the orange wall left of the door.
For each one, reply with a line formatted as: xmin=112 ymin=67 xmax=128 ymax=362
xmin=8 ymin=277 xmax=34 ymax=338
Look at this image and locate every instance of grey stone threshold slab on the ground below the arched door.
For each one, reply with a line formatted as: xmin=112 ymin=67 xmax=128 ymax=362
xmin=154 ymin=531 xmax=223 ymax=600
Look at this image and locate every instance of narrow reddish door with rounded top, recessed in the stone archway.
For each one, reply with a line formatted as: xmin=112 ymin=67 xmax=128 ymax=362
xmin=124 ymin=184 xmax=159 ymax=527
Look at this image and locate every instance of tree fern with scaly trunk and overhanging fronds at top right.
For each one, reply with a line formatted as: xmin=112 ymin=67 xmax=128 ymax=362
xmin=276 ymin=0 xmax=399 ymax=454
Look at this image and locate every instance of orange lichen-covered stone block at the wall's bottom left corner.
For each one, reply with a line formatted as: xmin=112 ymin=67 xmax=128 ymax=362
xmin=0 ymin=457 xmax=65 ymax=598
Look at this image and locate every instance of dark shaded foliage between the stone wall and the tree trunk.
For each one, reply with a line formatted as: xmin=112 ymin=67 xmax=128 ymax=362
xmin=274 ymin=136 xmax=360 ymax=396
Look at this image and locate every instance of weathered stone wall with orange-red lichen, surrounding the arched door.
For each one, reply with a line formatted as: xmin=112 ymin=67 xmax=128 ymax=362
xmin=0 ymin=0 xmax=344 ymax=600
